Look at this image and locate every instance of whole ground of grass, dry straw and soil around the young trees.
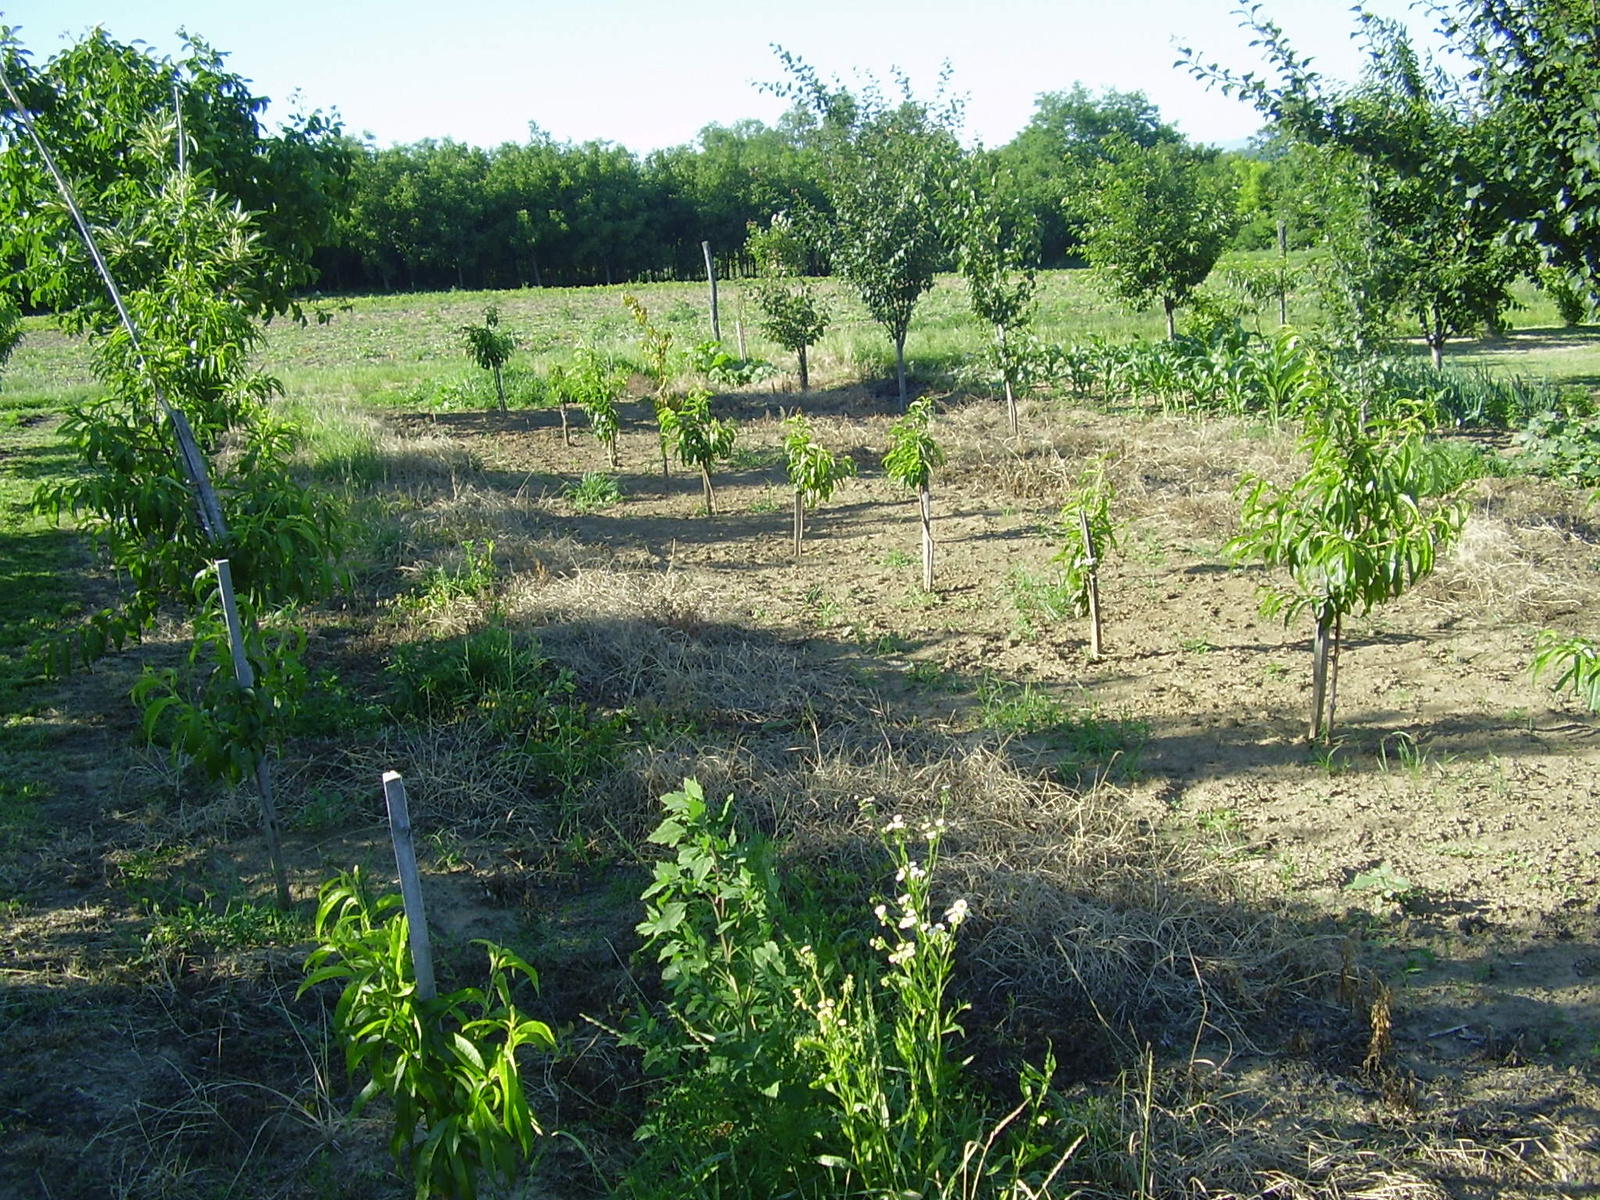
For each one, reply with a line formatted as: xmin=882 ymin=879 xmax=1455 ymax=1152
xmin=9 ymin=272 xmax=1600 ymax=1200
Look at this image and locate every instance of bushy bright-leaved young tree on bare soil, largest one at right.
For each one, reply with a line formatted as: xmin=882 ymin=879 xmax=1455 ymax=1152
xmin=1227 ymin=403 xmax=1466 ymax=741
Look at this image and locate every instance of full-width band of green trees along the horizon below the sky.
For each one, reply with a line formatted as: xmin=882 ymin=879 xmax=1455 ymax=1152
xmin=0 ymin=0 xmax=1600 ymax=366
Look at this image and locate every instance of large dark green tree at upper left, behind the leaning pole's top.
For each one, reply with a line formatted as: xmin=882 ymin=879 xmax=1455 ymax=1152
xmin=0 ymin=29 xmax=350 ymax=320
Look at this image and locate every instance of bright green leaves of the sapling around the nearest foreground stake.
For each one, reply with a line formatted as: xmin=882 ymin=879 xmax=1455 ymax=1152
xmin=299 ymin=870 xmax=555 ymax=1200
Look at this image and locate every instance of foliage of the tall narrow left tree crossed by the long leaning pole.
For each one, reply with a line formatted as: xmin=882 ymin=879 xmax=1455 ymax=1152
xmin=34 ymin=165 xmax=342 ymax=681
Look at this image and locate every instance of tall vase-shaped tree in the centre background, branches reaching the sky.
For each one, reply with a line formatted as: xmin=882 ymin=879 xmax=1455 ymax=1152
xmin=764 ymin=51 xmax=962 ymax=408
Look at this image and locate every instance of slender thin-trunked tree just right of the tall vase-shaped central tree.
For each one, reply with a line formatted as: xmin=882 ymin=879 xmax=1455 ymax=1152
xmin=954 ymin=176 xmax=1038 ymax=438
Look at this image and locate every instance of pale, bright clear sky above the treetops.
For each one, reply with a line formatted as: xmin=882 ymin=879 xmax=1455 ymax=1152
xmin=0 ymin=0 xmax=1452 ymax=154
